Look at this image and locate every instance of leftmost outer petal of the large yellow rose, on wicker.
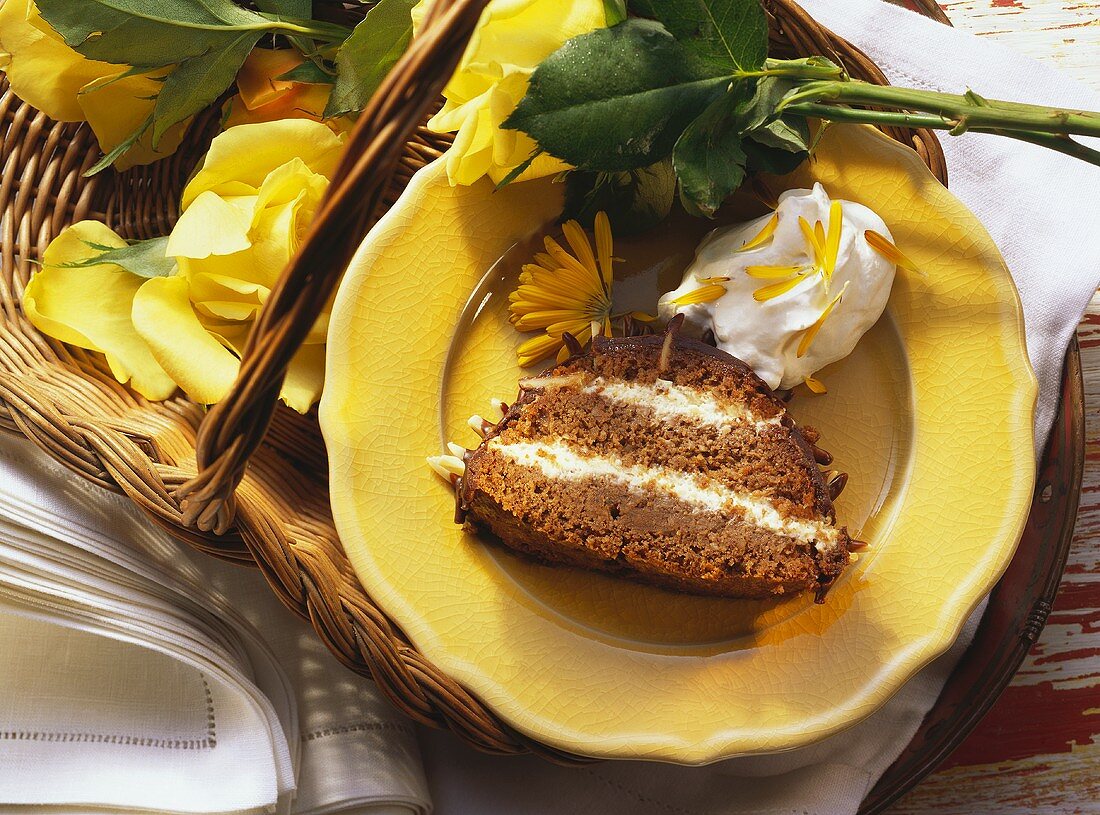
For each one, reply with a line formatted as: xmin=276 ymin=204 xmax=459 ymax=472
xmin=23 ymin=221 xmax=176 ymax=399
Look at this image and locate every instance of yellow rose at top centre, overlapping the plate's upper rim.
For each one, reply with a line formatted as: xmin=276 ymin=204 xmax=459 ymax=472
xmin=413 ymin=0 xmax=607 ymax=185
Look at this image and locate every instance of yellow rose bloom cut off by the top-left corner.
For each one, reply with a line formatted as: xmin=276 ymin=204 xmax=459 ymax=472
xmin=0 ymin=0 xmax=187 ymax=169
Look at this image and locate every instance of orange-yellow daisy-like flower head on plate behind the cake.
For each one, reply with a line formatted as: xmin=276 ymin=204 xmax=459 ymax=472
xmin=508 ymin=212 xmax=620 ymax=367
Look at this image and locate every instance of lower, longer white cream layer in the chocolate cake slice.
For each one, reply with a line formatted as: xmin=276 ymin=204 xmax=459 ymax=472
xmin=487 ymin=437 xmax=837 ymax=552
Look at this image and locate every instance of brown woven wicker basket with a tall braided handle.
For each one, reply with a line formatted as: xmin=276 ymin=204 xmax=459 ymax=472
xmin=0 ymin=0 xmax=946 ymax=761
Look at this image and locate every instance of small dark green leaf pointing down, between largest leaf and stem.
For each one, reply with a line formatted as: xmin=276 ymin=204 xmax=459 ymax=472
xmin=672 ymin=85 xmax=747 ymax=218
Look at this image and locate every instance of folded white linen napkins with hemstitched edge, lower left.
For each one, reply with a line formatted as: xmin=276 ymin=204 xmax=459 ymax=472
xmin=0 ymin=434 xmax=430 ymax=815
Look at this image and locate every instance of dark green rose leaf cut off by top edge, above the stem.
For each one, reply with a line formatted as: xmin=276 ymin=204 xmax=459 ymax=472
xmin=631 ymin=0 xmax=768 ymax=74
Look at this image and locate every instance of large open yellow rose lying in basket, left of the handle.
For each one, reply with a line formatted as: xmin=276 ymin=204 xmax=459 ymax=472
xmin=23 ymin=119 xmax=344 ymax=412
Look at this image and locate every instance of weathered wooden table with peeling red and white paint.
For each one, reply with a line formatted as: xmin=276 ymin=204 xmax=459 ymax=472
xmin=891 ymin=0 xmax=1100 ymax=815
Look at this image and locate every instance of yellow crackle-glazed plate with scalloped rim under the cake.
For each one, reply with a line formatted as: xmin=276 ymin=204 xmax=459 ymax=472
xmin=320 ymin=126 xmax=1036 ymax=763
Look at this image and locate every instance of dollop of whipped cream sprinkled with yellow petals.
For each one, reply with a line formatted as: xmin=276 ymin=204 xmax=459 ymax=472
xmin=658 ymin=184 xmax=895 ymax=388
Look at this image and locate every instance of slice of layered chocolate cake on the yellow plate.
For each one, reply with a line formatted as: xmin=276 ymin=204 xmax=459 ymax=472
xmin=455 ymin=328 xmax=851 ymax=598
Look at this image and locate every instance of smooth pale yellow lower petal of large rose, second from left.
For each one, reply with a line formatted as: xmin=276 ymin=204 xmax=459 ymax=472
xmin=133 ymin=276 xmax=240 ymax=405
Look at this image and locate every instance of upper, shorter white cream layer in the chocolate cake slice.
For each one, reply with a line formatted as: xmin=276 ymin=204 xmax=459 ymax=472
xmin=584 ymin=377 xmax=783 ymax=432
